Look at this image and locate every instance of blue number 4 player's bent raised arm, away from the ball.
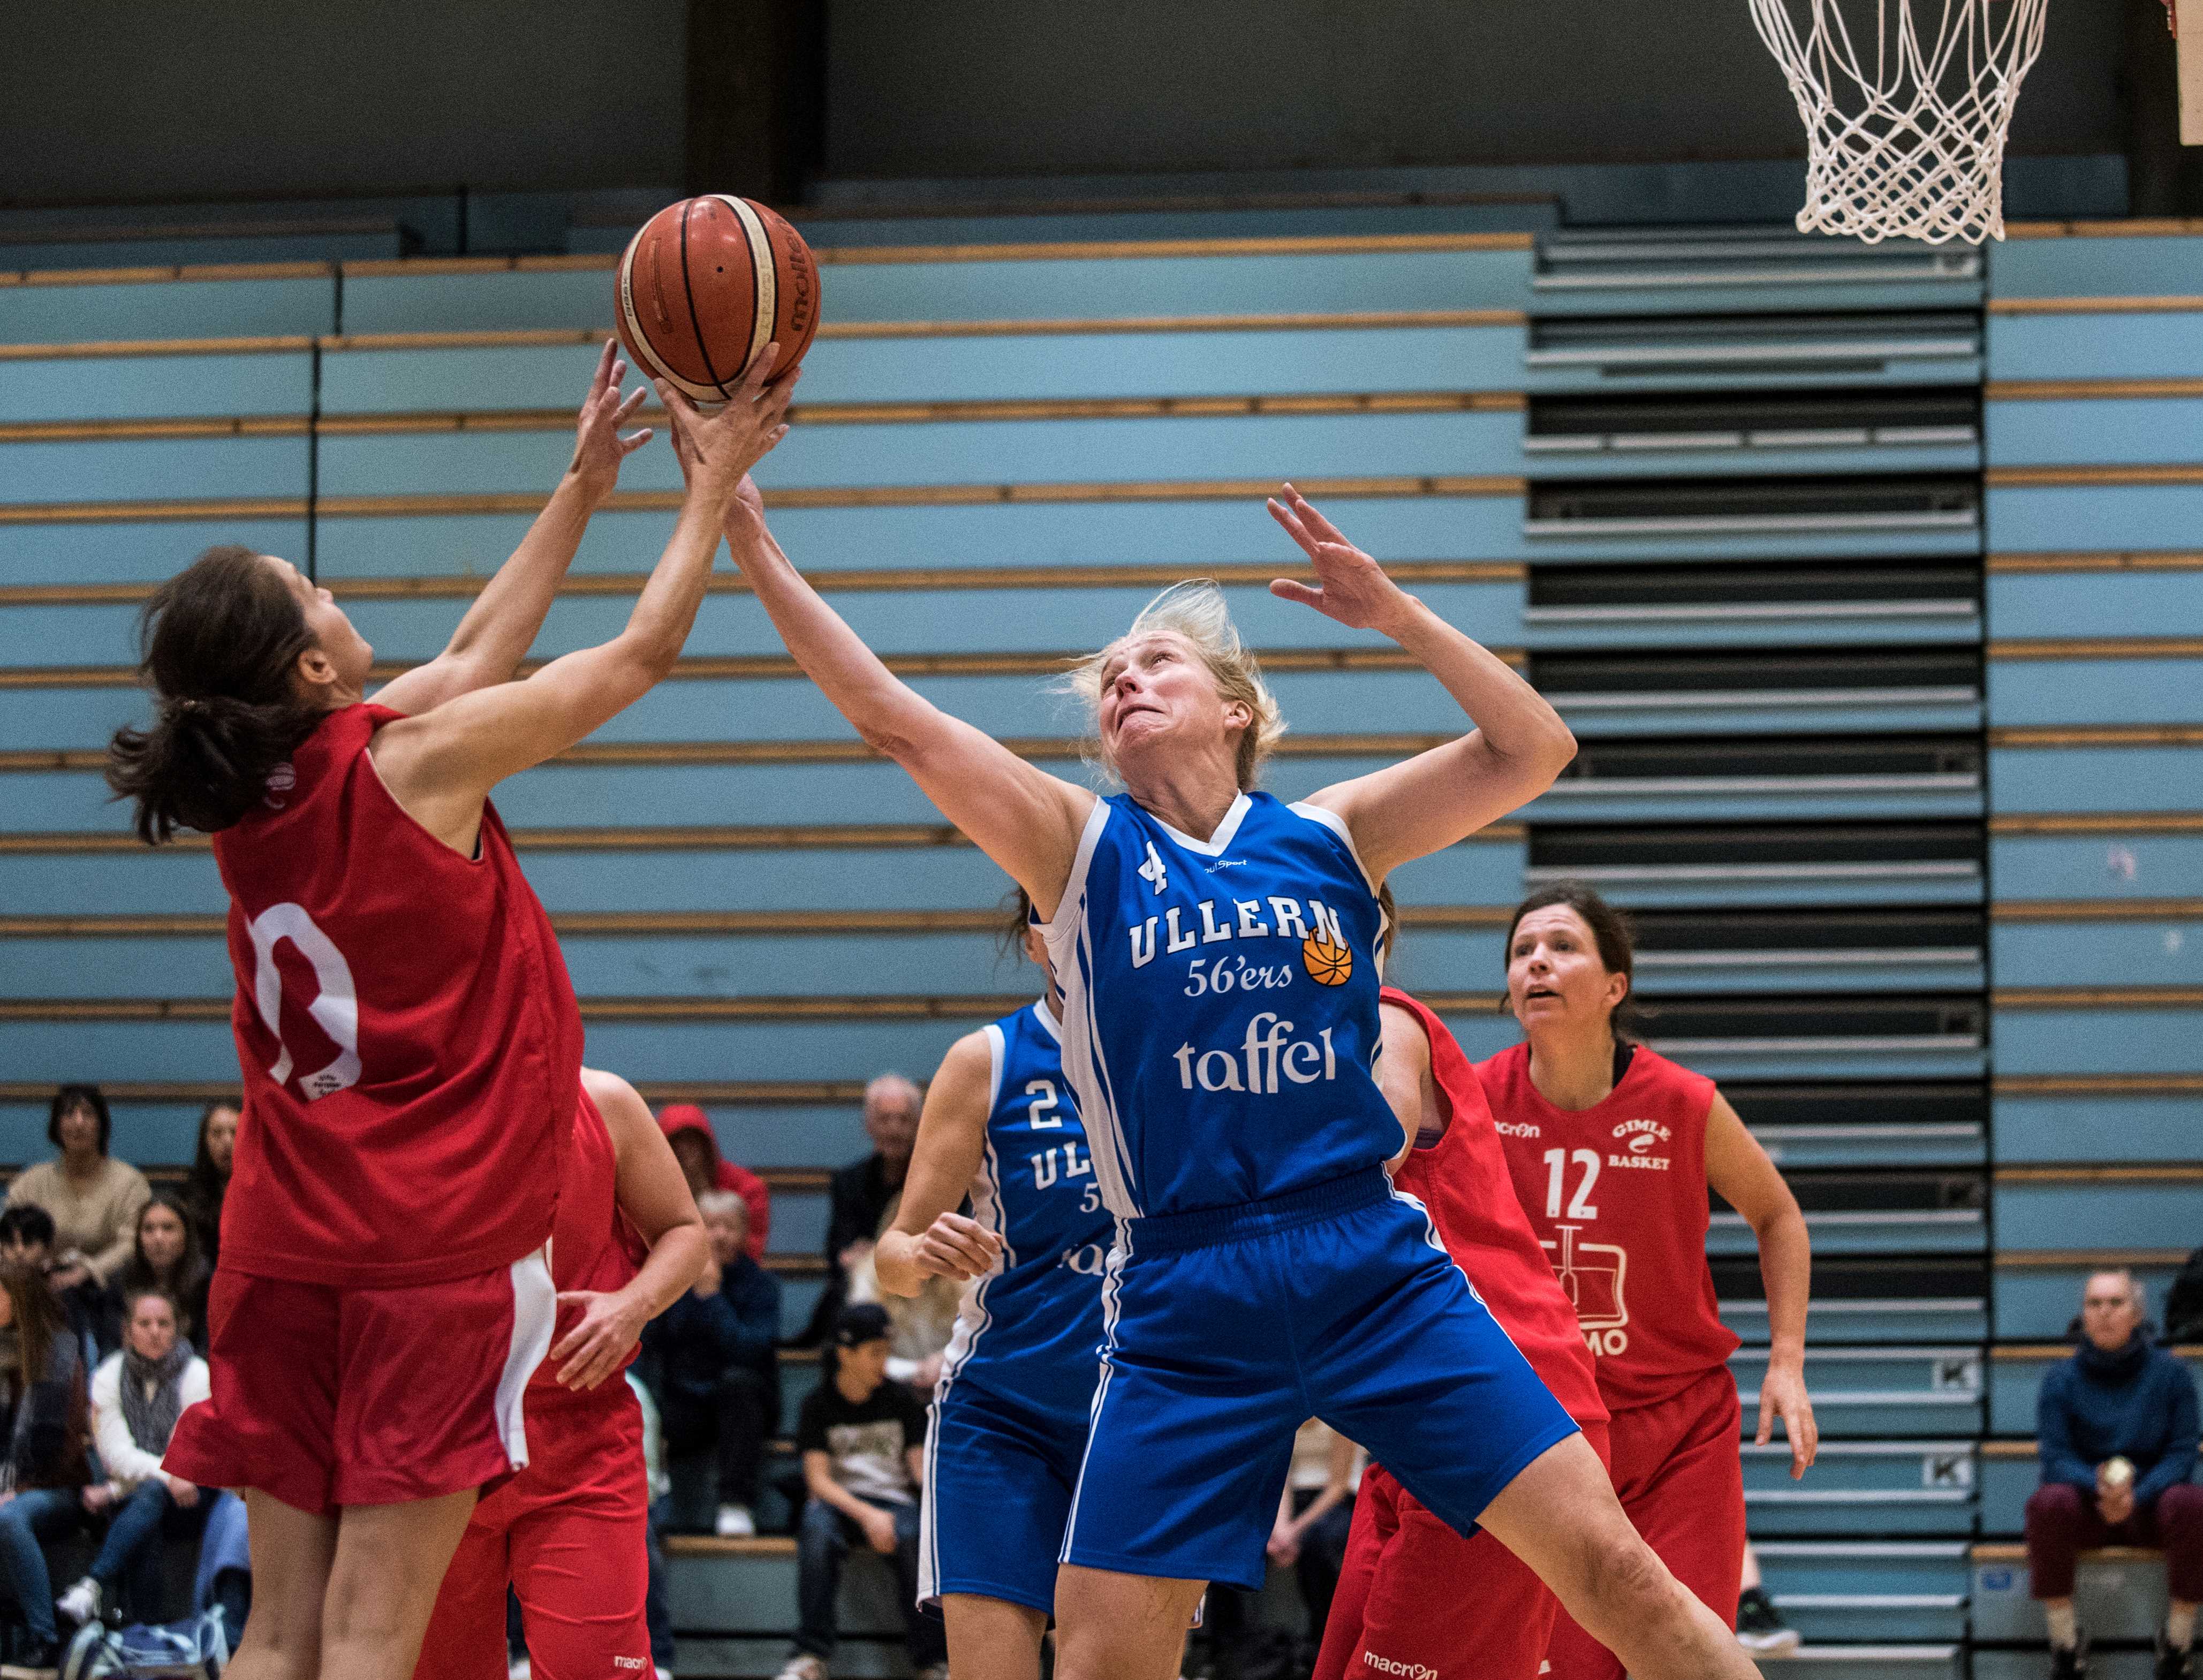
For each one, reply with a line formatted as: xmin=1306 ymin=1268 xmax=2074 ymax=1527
xmin=1269 ymin=484 xmax=1575 ymax=881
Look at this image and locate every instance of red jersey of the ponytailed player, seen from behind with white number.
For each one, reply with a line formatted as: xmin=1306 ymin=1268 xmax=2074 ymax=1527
xmin=214 ymin=704 xmax=581 ymax=1288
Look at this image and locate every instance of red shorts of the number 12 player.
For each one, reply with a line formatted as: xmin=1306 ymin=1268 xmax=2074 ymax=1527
xmin=1549 ymin=1365 xmax=1745 ymax=1680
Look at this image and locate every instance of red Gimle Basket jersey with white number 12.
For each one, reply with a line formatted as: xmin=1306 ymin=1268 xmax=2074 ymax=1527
xmin=1476 ymin=1044 xmax=1736 ymax=1411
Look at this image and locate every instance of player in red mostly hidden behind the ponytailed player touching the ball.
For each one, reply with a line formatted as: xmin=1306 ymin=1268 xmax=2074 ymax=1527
xmin=414 ymin=1068 xmax=711 ymax=1680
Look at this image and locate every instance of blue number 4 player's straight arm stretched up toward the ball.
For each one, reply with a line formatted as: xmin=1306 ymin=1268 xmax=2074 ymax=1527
xmin=727 ymin=496 xmax=1095 ymax=916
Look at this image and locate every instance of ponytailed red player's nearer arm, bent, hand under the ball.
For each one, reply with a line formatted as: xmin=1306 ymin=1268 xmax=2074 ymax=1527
xmin=375 ymin=348 xmax=796 ymax=852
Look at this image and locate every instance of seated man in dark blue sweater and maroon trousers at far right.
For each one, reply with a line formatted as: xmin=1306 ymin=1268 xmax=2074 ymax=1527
xmin=2027 ymin=1271 xmax=2203 ymax=1680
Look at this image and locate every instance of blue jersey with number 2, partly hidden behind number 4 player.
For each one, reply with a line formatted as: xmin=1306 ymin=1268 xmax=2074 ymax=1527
xmin=943 ymin=1002 xmax=1115 ymax=1427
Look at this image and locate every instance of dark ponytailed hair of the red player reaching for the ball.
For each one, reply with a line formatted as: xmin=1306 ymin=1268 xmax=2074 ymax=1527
xmin=108 ymin=544 xmax=322 ymax=846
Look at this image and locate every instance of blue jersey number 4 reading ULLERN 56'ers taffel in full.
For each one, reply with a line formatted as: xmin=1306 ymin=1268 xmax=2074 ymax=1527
xmin=1044 ymin=793 xmax=1401 ymax=1220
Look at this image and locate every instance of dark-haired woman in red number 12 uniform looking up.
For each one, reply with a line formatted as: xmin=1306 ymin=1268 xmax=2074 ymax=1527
xmin=1476 ymin=885 xmax=1820 ymax=1680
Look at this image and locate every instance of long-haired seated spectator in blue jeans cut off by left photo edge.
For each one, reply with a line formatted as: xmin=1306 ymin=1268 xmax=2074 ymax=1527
xmin=0 ymin=1266 xmax=90 ymax=1680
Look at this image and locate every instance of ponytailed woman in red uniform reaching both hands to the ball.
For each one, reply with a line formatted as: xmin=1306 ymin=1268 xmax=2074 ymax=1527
xmin=108 ymin=346 xmax=796 ymax=1680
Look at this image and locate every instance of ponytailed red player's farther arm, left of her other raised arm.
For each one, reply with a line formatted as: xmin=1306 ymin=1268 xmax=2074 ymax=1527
xmin=375 ymin=339 xmax=650 ymax=718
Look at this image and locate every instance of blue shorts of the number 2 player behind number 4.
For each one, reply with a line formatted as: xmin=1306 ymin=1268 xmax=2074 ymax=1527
xmin=919 ymin=1352 xmax=1097 ymax=1611
